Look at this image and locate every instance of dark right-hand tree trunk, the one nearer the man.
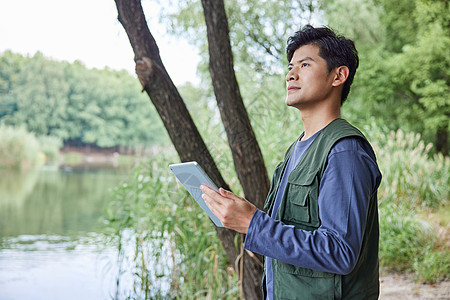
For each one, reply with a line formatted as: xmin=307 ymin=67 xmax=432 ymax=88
xmin=202 ymin=0 xmax=269 ymax=299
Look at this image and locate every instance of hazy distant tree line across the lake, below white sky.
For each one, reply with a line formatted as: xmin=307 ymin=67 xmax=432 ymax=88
xmin=0 ymin=51 xmax=167 ymax=148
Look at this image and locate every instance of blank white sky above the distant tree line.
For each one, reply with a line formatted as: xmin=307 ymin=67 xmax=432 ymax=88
xmin=0 ymin=0 xmax=199 ymax=85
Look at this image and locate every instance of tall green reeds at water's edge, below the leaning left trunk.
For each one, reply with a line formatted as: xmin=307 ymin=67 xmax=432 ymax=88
xmin=106 ymin=156 xmax=238 ymax=299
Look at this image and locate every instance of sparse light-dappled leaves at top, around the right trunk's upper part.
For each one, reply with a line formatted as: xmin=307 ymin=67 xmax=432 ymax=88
xmin=159 ymin=0 xmax=320 ymax=82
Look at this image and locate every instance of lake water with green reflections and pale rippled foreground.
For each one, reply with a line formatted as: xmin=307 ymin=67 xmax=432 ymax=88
xmin=0 ymin=168 xmax=132 ymax=300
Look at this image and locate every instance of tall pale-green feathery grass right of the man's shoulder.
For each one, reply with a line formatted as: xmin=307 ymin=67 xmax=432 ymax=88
xmin=365 ymin=124 xmax=450 ymax=209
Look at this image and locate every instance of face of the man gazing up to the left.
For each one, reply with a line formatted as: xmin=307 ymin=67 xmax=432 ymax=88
xmin=286 ymin=45 xmax=333 ymax=109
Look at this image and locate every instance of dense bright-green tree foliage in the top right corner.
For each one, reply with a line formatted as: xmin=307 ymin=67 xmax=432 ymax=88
xmin=342 ymin=0 xmax=450 ymax=154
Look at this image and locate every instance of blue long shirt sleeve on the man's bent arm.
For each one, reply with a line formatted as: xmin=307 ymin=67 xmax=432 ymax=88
xmin=244 ymin=138 xmax=381 ymax=275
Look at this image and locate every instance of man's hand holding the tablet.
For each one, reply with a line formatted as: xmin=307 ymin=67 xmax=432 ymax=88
xmin=200 ymin=185 xmax=256 ymax=233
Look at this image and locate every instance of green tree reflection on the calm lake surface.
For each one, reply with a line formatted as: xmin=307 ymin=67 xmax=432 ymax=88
xmin=0 ymin=171 xmax=120 ymax=237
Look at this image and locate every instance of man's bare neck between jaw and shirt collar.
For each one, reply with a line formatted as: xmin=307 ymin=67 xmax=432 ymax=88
xmin=300 ymin=102 xmax=341 ymax=140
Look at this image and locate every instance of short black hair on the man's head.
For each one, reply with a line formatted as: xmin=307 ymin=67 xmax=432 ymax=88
xmin=286 ymin=25 xmax=359 ymax=105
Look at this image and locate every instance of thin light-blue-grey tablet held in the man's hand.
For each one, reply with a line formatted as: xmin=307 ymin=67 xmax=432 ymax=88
xmin=169 ymin=161 xmax=223 ymax=227
